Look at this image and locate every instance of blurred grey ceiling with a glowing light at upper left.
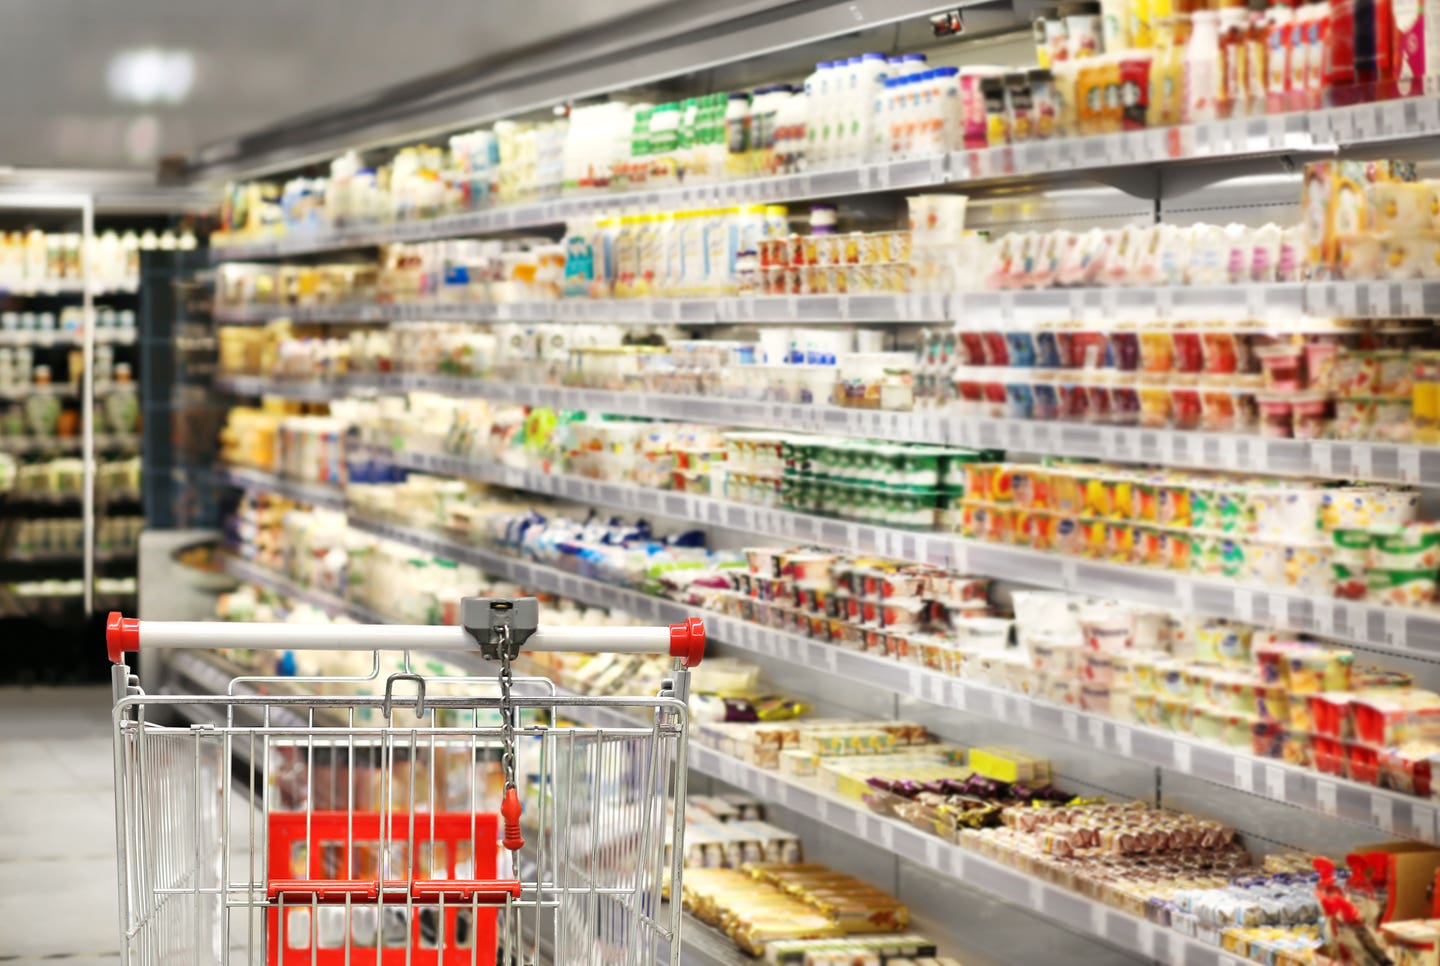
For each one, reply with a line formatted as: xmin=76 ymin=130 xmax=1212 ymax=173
xmin=0 ymin=0 xmax=667 ymax=168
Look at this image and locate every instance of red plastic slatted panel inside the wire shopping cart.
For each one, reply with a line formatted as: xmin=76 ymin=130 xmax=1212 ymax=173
xmin=265 ymin=812 xmax=510 ymax=966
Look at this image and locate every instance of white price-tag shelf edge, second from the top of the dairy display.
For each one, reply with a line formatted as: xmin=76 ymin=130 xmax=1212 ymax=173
xmin=205 ymin=281 xmax=1440 ymax=331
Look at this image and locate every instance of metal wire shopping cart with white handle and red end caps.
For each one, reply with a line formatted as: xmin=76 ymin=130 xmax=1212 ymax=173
xmin=107 ymin=597 xmax=704 ymax=966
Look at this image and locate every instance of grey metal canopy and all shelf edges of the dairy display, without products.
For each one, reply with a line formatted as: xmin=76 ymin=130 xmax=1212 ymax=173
xmin=168 ymin=1 xmax=1440 ymax=966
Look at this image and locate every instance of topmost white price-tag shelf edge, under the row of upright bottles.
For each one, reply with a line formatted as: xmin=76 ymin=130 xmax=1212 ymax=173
xmin=210 ymin=95 xmax=1440 ymax=262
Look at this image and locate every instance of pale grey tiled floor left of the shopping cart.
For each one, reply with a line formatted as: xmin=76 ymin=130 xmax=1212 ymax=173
xmin=0 ymin=687 xmax=120 ymax=966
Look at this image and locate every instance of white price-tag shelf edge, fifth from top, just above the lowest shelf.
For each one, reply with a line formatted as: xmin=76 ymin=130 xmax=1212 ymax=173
xmin=342 ymin=515 xmax=1440 ymax=842
